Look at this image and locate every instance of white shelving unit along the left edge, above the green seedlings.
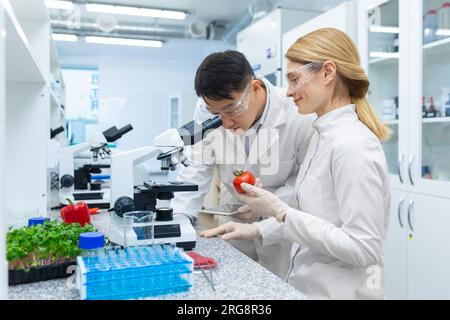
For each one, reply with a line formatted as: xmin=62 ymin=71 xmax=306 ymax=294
xmin=0 ymin=0 xmax=65 ymax=224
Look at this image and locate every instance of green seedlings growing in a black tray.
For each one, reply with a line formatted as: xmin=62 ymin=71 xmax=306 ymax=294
xmin=6 ymin=221 xmax=95 ymax=285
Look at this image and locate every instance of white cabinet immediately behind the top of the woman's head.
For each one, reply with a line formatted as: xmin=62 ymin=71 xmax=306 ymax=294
xmin=282 ymin=2 xmax=357 ymax=86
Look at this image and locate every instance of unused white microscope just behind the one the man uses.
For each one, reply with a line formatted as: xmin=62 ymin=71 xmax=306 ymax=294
xmin=59 ymin=124 xmax=133 ymax=209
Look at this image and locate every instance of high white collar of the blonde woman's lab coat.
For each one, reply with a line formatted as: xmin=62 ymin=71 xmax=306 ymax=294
xmin=313 ymin=104 xmax=358 ymax=133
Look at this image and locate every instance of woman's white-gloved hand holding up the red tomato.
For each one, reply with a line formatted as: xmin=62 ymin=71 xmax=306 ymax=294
xmin=237 ymin=183 xmax=289 ymax=222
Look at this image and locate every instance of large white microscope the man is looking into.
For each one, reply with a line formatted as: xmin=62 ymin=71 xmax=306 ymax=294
xmin=108 ymin=117 xmax=222 ymax=250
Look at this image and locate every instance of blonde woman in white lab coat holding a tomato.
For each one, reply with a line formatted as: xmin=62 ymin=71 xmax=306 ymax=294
xmin=202 ymin=29 xmax=390 ymax=299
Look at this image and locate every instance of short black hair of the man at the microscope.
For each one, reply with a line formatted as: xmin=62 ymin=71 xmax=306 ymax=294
xmin=195 ymin=50 xmax=255 ymax=101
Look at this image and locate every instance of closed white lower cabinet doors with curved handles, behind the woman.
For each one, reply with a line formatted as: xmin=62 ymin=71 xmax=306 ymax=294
xmin=384 ymin=189 xmax=450 ymax=299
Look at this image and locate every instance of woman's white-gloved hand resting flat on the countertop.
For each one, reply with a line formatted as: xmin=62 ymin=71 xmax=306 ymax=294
xmin=200 ymin=221 xmax=261 ymax=240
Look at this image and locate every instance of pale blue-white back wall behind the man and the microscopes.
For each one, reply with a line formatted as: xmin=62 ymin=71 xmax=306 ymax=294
xmin=58 ymin=40 xmax=232 ymax=149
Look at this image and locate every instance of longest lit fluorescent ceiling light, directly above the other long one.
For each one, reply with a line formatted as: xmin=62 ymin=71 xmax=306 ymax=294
xmin=86 ymin=3 xmax=186 ymax=20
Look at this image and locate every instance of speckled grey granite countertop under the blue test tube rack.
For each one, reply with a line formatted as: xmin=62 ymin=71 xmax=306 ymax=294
xmin=9 ymin=212 xmax=306 ymax=300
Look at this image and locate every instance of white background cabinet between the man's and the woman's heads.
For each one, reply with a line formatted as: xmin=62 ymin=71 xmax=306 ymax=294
xmin=237 ymin=8 xmax=320 ymax=85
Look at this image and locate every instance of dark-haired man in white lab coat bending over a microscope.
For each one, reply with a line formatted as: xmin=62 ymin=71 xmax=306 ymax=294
xmin=173 ymin=51 xmax=315 ymax=277
